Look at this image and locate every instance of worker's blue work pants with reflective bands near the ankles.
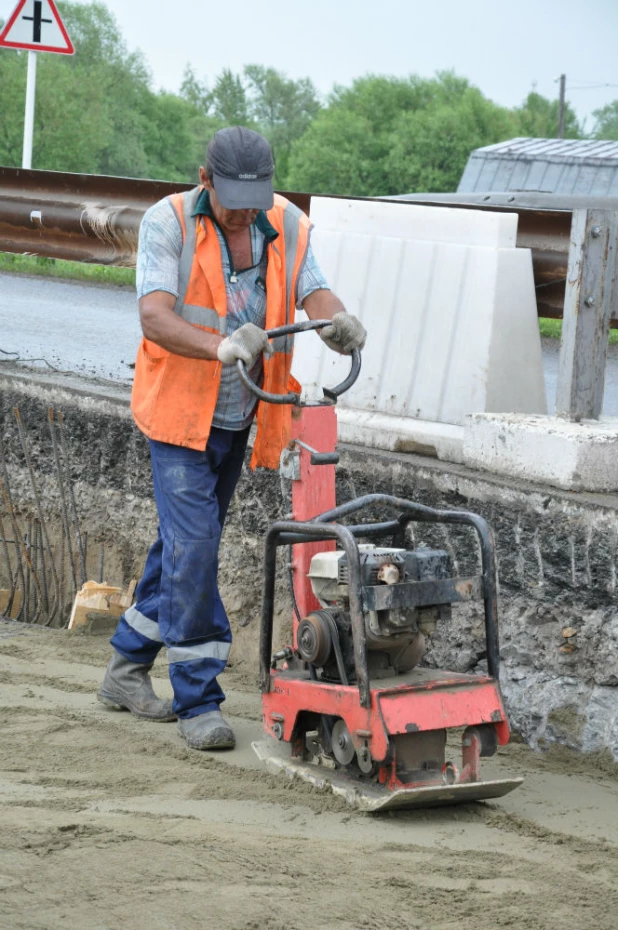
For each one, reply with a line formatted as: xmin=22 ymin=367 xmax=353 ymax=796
xmin=111 ymin=427 xmax=249 ymax=717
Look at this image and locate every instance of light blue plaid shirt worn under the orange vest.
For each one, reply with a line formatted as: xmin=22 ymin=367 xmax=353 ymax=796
xmin=137 ymin=191 xmax=328 ymax=430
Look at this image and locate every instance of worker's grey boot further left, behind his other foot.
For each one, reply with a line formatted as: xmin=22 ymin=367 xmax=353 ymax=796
xmin=97 ymin=650 xmax=176 ymax=722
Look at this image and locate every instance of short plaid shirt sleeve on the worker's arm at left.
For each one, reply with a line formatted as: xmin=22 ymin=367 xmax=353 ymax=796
xmin=135 ymin=200 xmax=182 ymax=299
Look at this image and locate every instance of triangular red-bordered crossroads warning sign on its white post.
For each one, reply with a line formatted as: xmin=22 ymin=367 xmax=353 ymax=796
xmin=0 ymin=0 xmax=75 ymax=168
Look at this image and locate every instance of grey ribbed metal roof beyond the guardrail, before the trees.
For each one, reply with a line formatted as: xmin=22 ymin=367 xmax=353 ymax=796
xmin=457 ymin=139 xmax=618 ymax=197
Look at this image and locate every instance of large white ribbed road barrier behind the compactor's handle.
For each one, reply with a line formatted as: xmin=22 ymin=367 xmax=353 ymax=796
xmin=294 ymin=197 xmax=547 ymax=461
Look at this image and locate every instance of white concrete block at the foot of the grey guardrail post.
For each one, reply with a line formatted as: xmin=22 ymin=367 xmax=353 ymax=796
xmin=463 ymin=413 xmax=618 ymax=491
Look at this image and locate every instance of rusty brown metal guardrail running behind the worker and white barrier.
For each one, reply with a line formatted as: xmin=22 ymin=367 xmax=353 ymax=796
xmin=0 ymin=168 xmax=584 ymax=317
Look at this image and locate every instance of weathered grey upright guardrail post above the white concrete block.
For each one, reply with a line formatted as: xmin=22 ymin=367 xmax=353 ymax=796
xmin=556 ymin=210 xmax=618 ymax=420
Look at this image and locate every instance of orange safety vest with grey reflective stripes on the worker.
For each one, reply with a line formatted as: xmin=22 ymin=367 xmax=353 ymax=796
xmin=131 ymin=187 xmax=311 ymax=468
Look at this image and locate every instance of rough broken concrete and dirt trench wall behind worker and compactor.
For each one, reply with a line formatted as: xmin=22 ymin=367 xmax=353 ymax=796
xmin=0 ymin=368 xmax=618 ymax=760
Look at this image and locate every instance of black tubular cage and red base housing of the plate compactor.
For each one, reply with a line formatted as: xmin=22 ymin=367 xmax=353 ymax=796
xmin=255 ymin=494 xmax=509 ymax=790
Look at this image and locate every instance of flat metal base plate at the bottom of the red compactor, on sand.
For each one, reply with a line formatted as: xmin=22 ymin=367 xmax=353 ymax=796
xmin=251 ymin=739 xmax=523 ymax=812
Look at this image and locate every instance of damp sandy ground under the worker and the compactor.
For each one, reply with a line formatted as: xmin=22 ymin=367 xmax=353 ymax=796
xmin=0 ymin=621 xmax=618 ymax=930
